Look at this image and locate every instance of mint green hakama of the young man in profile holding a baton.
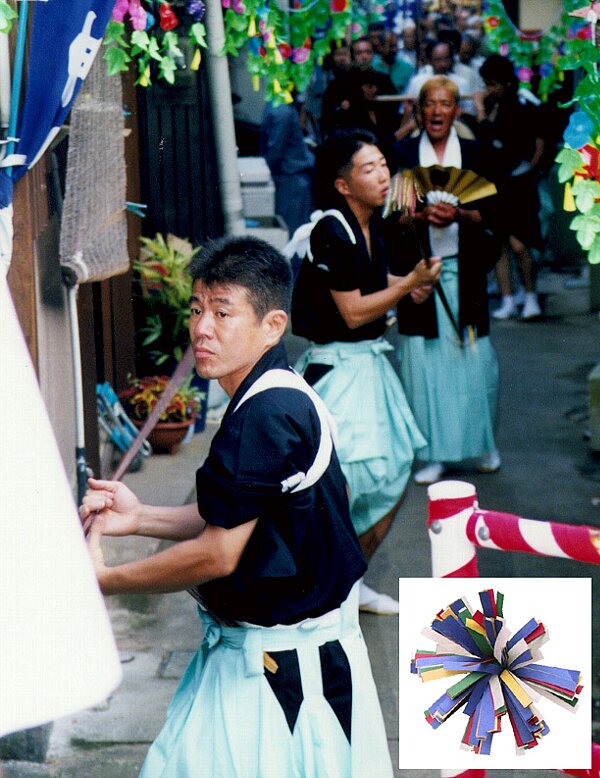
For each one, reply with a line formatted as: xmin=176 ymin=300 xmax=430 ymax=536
xmin=295 ymin=338 xmax=426 ymax=536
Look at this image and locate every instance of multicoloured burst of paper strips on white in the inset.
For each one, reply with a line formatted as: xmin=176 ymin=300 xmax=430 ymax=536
xmin=410 ymin=589 xmax=583 ymax=754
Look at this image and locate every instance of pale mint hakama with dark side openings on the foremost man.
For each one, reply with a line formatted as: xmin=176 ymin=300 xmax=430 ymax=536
xmin=140 ymin=584 xmax=393 ymax=778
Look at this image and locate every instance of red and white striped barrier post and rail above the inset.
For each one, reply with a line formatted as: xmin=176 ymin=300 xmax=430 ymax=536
xmin=427 ymin=481 xmax=600 ymax=778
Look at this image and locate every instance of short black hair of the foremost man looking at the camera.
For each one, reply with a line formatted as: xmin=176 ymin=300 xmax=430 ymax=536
xmin=189 ymin=235 xmax=292 ymax=320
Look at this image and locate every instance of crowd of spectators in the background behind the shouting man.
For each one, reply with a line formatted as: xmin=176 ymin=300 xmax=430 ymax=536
xmin=263 ymin=3 xmax=564 ymax=319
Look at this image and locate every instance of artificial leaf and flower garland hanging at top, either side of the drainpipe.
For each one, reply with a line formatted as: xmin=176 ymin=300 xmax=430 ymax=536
xmin=98 ymin=0 xmax=386 ymax=104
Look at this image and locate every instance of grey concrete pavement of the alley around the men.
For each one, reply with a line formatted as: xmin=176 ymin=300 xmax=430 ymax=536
xmin=4 ymin=273 xmax=600 ymax=778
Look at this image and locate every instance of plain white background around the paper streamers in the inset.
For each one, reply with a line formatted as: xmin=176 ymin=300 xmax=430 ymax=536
xmin=399 ymin=578 xmax=592 ymax=770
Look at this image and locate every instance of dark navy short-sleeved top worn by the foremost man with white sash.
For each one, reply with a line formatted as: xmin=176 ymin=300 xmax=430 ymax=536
xmin=196 ymin=345 xmax=366 ymax=626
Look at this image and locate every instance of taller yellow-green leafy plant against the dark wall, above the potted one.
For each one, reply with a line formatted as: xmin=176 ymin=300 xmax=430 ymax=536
xmin=133 ymin=232 xmax=199 ymax=367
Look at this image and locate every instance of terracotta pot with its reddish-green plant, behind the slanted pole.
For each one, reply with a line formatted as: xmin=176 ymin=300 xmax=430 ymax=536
xmin=119 ymin=375 xmax=205 ymax=454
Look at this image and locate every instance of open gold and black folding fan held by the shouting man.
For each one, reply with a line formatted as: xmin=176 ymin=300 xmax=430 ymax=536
xmin=383 ymin=165 xmax=497 ymax=217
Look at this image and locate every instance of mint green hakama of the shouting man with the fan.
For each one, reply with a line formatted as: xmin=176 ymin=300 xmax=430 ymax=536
xmin=398 ymin=258 xmax=498 ymax=463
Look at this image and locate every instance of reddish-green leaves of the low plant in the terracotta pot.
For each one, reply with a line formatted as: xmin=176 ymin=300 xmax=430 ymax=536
xmin=119 ymin=375 xmax=206 ymax=423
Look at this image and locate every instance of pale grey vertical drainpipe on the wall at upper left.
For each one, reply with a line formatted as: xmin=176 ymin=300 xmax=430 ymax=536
xmin=206 ymin=0 xmax=246 ymax=235
